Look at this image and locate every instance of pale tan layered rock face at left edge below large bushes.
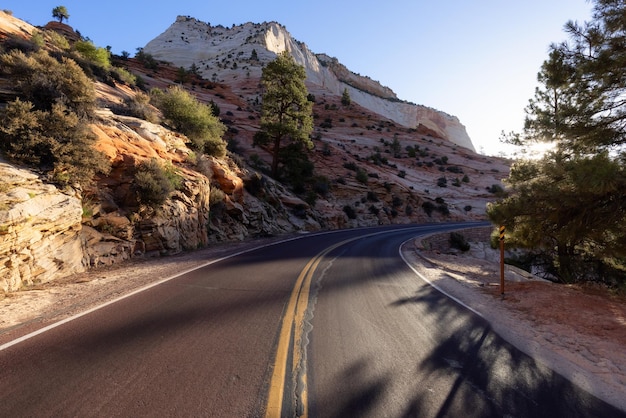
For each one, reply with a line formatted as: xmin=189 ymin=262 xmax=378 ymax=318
xmin=0 ymin=162 xmax=85 ymax=292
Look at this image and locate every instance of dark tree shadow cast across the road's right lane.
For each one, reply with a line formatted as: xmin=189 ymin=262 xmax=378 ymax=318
xmin=392 ymin=286 xmax=626 ymax=417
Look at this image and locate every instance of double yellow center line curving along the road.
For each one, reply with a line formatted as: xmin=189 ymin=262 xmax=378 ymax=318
xmin=265 ymin=237 xmax=354 ymax=418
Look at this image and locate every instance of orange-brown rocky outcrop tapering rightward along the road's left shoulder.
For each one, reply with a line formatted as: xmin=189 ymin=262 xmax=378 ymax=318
xmin=83 ymin=111 xmax=320 ymax=260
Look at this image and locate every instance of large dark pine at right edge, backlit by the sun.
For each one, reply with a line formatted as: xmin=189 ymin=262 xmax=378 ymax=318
xmin=488 ymin=0 xmax=626 ymax=282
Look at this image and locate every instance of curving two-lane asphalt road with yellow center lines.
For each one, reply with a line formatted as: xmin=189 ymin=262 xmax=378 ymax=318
xmin=0 ymin=225 xmax=626 ymax=417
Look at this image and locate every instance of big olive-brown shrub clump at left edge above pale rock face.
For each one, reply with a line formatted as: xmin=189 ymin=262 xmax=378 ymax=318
xmin=0 ymin=46 xmax=110 ymax=185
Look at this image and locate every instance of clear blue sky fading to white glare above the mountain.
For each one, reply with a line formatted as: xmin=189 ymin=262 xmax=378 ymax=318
xmin=0 ymin=0 xmax=593 ymax=155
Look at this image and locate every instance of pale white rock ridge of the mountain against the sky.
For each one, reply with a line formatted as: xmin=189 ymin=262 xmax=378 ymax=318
xmin=143 ymin=16 xmax=476 ymax=151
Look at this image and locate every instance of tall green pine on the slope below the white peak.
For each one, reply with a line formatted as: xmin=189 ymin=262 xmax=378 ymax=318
xmin=254 ymin=51 xmax=313 ymax=178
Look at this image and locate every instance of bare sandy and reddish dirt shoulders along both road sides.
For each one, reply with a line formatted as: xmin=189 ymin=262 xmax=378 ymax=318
xmin=0 ymin=233 xmax=626 ymax=410
